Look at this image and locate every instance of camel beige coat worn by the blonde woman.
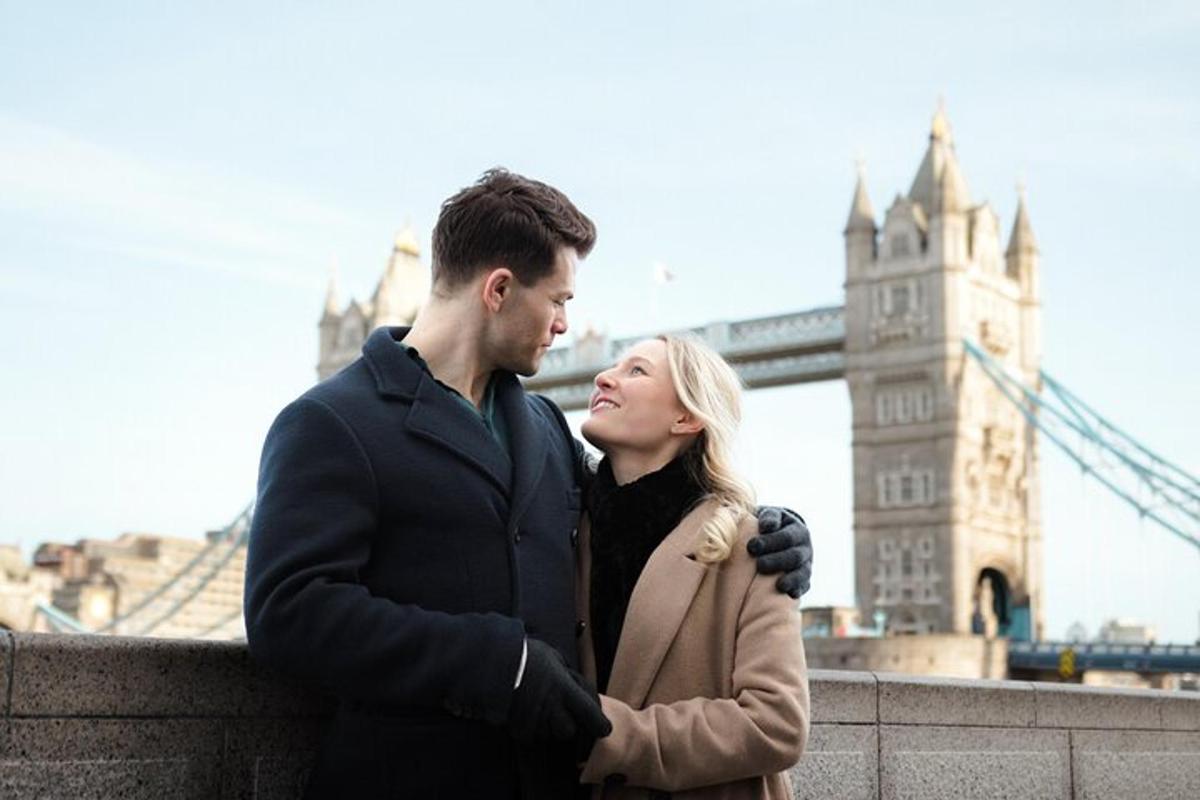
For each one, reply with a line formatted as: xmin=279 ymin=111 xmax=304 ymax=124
xmin=576 ymin=501 xmax=809 ymax=800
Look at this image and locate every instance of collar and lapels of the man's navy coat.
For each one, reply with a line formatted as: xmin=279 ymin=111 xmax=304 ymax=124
xmin=362 ymin=327 xmax=550 ymax=513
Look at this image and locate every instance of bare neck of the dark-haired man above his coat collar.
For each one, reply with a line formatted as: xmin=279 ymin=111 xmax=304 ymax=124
xmin=404 ymin=299 xmax=496 ymax=408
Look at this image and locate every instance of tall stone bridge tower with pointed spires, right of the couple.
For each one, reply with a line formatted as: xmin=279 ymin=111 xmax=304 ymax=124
xmin=845 ymin=109 xmax=1042 ymax=638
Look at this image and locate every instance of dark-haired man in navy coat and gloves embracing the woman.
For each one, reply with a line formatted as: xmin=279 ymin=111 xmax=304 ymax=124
xmin=246 ymin=170 xmax=811 ymax=798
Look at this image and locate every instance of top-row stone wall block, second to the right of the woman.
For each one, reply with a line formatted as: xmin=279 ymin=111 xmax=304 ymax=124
xmin=876 ymin=673 xmax=1036 ymax=728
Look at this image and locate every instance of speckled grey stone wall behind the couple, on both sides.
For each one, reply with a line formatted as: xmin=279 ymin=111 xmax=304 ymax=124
xmin=0 ymin=632 xmax=1200 ymax=800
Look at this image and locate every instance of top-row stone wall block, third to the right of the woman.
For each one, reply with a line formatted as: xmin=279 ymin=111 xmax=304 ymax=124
xmin=1033 ymin=682 xmax=1164 ymax=730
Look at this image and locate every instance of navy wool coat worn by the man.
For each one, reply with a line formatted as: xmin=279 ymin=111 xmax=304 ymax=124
xmin=245 ymin=329 xmax=581 ymax=798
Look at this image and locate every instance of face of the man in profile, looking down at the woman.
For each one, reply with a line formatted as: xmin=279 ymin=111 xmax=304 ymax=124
xmin=493 ymin=247 xmax=578 ymax=375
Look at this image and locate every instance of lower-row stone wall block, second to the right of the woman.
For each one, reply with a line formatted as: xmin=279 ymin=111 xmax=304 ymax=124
xmin=880 ymin=726 xmax=1070 ymax=800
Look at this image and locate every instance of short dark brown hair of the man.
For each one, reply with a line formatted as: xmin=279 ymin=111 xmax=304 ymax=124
xmin=433 ymin=167 xmax=596 ymax=288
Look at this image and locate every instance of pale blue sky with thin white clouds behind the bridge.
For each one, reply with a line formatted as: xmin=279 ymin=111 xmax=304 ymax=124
xmin=0 ymin=0 xmax=1200 ymax=642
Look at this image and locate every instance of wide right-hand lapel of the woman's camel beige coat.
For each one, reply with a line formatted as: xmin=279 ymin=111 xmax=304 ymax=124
xmin=608 ymin=501 xmax=712 ymax=709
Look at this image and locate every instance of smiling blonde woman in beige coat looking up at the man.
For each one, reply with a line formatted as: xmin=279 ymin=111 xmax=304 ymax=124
xmin=576 ymin=336 xmax=809 ymax=800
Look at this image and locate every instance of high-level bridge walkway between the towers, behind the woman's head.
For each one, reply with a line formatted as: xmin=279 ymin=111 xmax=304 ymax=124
xmin=524 ymin=306 xmax=846 ymax=411
